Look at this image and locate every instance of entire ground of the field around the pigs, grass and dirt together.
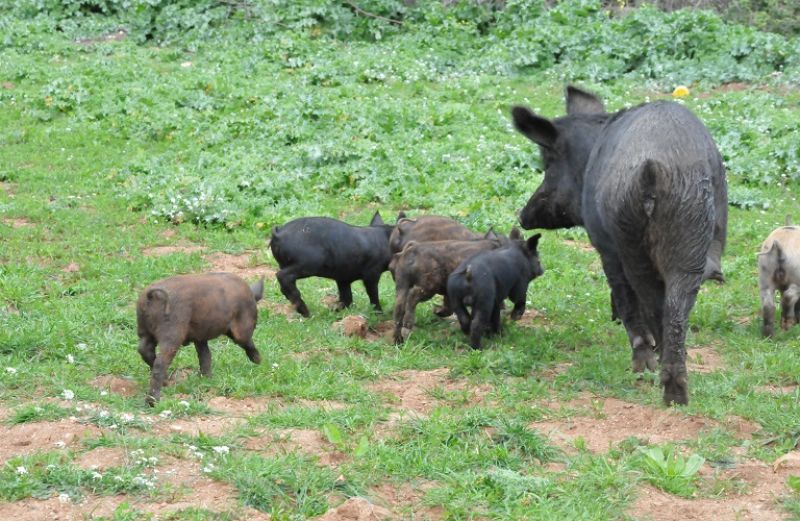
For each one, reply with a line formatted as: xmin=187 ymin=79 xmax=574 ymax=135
xmin=0 ymin=2 xmax=800 ymax=520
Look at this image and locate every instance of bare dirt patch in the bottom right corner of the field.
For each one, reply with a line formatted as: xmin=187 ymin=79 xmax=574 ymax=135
xmin=628 ymin=461 xmax=790 ymax=521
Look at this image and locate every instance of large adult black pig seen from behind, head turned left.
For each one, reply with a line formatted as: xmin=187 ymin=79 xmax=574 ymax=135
xmin=512 ymin=87 xmax=727 ymax=404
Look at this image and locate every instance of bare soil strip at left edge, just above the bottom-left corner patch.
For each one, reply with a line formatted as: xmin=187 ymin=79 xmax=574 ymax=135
xmin=0 ymin=419 xmax=100 ymax=464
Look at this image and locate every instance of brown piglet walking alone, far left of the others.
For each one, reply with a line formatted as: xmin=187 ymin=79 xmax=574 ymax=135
xmin=136 ymin=273 xmax=264 ymax=406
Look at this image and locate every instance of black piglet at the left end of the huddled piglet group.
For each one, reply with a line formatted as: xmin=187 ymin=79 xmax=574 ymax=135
xmin=270 ymin=212 xmax=394 ymax=317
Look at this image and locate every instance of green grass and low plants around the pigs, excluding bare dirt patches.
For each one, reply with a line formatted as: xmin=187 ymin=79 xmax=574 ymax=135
xmin=0 ymin=2 xmax=800 ymax=520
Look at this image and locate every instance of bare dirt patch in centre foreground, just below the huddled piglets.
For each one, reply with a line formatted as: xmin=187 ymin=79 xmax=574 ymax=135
xmin=367 ymin=367 xmax=491 ymax=416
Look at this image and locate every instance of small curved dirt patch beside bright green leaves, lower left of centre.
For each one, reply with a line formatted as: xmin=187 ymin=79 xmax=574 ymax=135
xmin=245 ymin=429 xmax=347 ymax=466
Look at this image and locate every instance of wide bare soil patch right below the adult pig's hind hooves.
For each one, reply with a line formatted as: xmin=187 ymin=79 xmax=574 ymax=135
xmin=530 ymin=396 xmax=759 ymax=453
